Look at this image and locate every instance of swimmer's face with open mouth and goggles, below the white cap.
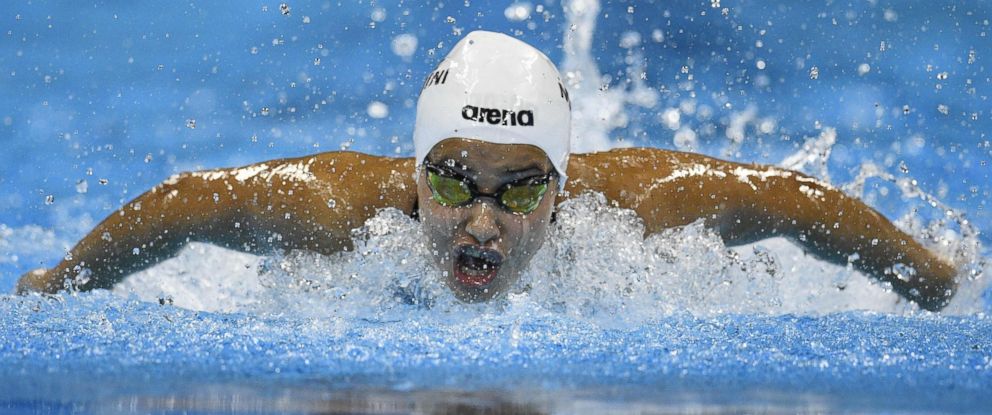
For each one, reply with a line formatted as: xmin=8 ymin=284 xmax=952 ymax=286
xmin=417 ymin=138 xmax=559 ymax=302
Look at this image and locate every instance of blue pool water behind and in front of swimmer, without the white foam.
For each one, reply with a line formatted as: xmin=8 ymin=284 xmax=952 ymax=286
xmin=0 ymin=0 xmax=992 ymax=412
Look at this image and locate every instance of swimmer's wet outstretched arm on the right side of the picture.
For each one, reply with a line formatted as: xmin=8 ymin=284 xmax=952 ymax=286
xmin=570 ymin=149 xmax=956 ymax=310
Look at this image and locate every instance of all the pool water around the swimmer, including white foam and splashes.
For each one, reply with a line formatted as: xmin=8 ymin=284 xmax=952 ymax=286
xmin=0 ymin=0 xmax=992 ymax=414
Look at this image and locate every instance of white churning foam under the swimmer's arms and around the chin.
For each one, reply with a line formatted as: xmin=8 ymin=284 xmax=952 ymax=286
xmin=115 ymin=194 xmax=982 ymax=326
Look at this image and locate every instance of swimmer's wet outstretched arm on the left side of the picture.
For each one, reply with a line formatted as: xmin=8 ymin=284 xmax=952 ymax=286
xmin=17 ymin=153 xmax=415 ymax=293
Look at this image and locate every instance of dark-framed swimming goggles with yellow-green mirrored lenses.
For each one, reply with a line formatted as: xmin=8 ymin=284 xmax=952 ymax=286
xmin=424 ymin=160 xmax=556 ymax=215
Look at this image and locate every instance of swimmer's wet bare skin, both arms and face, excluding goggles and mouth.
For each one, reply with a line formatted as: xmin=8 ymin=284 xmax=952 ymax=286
xmin=17 ymin=139 xmax=957 ymax=310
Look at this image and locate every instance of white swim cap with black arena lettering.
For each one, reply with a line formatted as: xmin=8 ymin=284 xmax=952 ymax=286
xmin=413 ymin=31 xmax=572 ymax=187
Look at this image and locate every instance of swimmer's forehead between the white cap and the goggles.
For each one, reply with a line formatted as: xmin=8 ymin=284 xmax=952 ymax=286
xmin=427 ymin=138 xmax=554 ymax=174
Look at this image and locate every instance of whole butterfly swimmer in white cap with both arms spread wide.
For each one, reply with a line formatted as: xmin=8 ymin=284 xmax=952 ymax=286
xmin=17 ymin=31 xmax=956 ymax=310
